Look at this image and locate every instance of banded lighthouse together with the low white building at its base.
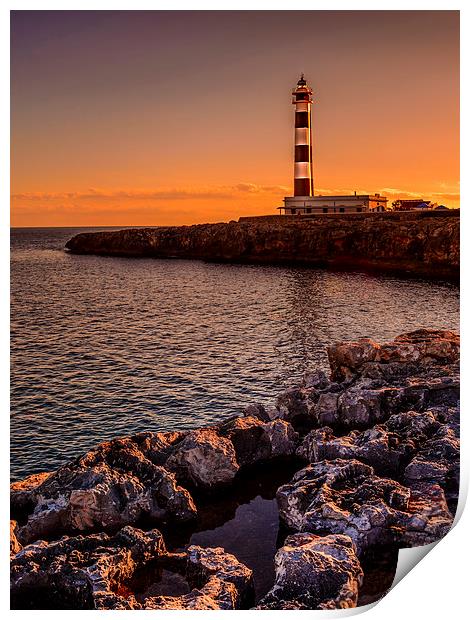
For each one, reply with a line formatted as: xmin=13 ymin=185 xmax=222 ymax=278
xmin=277 ymin=73 xmax=387 ymax=216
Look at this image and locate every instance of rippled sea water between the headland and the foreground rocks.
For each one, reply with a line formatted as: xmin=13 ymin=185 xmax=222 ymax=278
xmin=11 ymin=229 xmax=459 ymax=479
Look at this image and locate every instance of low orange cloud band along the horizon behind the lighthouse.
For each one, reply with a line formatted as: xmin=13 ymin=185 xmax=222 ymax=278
xmin=11 ymin=182 xmax=460 ymax=225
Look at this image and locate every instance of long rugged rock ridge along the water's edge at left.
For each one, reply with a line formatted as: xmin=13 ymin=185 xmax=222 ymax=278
xmin=11 ymin=418 xmax=299 ymax=544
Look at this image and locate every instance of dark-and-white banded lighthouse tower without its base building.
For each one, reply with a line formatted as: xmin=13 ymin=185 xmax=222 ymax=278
xmin=292 ymin=73 xmax=313 ymax=196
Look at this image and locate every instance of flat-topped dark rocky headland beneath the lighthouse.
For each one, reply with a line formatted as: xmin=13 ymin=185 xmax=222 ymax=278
xmin=66 ymin=211 xmax=460 ymax=279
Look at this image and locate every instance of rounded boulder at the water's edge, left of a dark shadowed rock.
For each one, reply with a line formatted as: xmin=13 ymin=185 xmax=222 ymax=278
xmin=165 ymin=428 xmax=239 ymax=488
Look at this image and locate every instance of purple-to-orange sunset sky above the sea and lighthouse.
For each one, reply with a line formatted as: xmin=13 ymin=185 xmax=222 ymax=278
xmin=11 ymin=11 xmax=459 ymax=226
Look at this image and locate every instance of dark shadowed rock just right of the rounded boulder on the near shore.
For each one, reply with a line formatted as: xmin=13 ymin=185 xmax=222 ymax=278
xmin=219 ymin=417 xmax=299 ymax=467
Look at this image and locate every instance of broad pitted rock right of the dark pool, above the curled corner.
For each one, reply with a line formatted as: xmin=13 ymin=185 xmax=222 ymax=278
xmin=276 ymin=459 xmax=452 ymax=552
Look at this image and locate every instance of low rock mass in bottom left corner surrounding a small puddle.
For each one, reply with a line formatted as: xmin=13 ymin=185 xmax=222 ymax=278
xmin=11 ymin=527 xmax=253 ymax=609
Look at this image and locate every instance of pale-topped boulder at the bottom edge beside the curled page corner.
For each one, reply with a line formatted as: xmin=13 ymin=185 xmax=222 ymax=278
xmin=256 ymin=533 xmax=363 ymax=609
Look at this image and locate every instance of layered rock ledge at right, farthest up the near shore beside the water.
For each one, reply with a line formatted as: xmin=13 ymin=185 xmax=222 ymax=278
xmin=258 ymin=330 xmax=460 ymax=433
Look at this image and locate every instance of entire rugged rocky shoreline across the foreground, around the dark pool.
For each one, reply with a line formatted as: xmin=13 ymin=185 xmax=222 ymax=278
xmin=10 ymin=329 xmax=460 ymax=609
